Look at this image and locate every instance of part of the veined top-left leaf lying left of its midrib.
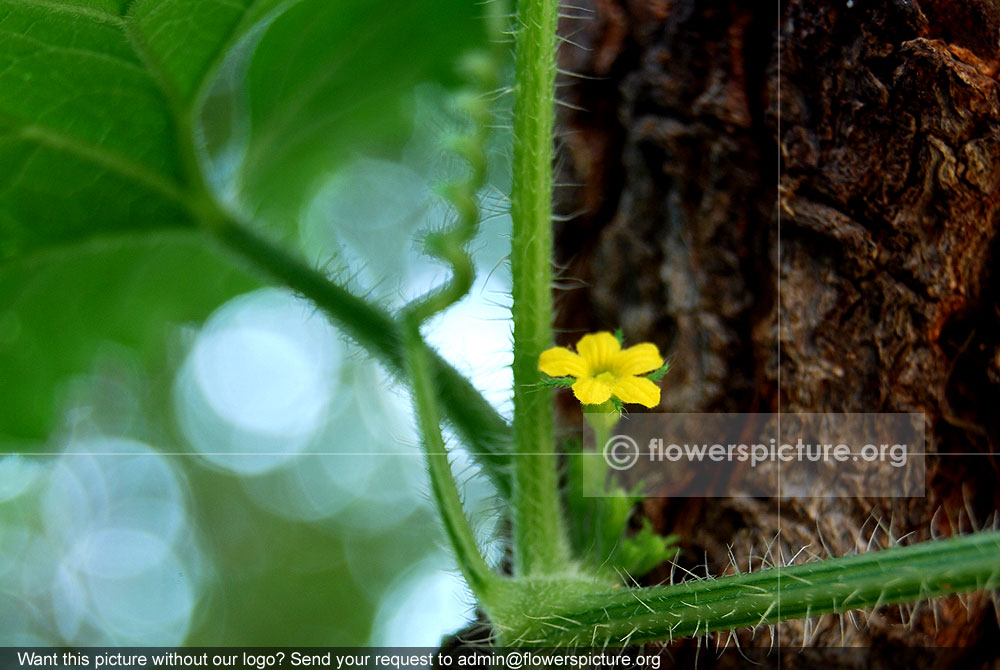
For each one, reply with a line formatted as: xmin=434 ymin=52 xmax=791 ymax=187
xmin=0 ymin=0 xmax=190 ymax=260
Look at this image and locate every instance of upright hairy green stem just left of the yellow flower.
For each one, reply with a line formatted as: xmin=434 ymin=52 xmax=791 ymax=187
xmin=511 ymin=0 xmax=569 ymax=575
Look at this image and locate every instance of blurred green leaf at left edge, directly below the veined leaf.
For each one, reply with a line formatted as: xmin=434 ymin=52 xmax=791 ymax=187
xmin=0 ymin=235 xmax=258 ymax=446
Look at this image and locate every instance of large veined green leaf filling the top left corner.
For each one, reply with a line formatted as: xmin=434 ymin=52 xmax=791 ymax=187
xmin=0 ymin=0 xmax=288 ymax=261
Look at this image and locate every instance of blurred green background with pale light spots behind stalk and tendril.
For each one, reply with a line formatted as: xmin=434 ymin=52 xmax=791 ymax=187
xmin=0 ymin=0 xmax=511 ymax=646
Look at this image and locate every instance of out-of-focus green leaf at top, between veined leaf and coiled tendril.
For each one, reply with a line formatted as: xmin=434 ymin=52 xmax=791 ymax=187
xmin=233 ymin=0 xmax=485 ymax=230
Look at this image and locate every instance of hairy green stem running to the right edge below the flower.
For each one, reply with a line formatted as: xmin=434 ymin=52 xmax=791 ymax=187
xmin=497 ymin=532 xmax=1000 ymax=646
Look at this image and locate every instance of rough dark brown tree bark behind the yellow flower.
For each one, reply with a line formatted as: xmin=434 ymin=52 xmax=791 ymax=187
xmin=556 ymin=0 xmax=1000 ymax=667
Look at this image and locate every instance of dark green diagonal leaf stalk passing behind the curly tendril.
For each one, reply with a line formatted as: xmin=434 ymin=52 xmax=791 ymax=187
xmin=207 ymin=215 xmax=511 ymax=497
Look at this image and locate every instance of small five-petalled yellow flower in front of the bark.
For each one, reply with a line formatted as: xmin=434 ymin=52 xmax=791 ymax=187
xmin=538 ymin=332 xmax=663 ymax=407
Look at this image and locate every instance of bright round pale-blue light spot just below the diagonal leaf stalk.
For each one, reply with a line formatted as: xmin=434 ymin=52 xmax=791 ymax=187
xmin=175 ymin=289 xmax=341 ymax=474
